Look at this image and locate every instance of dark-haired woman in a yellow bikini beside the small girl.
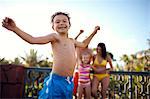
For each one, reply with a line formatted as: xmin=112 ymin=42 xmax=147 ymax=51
xmin=92 ymin=43 xmax=113 ymax=99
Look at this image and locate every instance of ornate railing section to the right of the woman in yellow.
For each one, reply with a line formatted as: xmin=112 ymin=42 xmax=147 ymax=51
xmin=108 ymin=71 xmax=150 ymax=99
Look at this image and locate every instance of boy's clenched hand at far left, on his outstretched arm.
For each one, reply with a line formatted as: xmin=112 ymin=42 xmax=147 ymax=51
xmin=2 ymin=17 xmax=16 ymax=31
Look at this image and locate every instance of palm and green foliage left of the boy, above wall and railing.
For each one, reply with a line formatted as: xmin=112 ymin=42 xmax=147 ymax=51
xmin=0 ymin=49 xmax=53 ymax=68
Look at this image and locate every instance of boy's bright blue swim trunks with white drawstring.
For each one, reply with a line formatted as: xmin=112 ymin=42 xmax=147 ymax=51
xmin=38 ymin=73 xmax=74 ymax=99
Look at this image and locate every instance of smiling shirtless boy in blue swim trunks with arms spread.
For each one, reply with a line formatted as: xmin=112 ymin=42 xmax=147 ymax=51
xmin=2 ymin=12 xmax=100 ymax=99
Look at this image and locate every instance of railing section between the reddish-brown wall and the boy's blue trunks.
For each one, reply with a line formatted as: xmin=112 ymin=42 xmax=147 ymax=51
xmin=24 ymin=67 xmax=51 ymax=99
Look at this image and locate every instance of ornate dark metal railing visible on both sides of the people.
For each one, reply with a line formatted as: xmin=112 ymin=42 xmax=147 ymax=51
xmin=24 ymin=68 xmax=150 ymax=99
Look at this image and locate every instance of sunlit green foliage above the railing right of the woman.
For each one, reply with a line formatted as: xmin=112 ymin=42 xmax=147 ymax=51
xmin=121 ymin=49 xmax=150 ymax=72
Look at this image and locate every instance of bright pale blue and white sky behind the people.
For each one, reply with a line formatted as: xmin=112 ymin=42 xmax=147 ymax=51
xmin=0 ymin=0 xmax=150 ymax=60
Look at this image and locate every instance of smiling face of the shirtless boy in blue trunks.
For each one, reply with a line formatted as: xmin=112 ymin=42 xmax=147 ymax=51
xmin=52 ymin=15 xmax=70 ymax=34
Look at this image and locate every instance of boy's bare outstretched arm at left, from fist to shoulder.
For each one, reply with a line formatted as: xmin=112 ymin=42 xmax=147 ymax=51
xmin=2 ymin=17 xmax=56 ymax=44
